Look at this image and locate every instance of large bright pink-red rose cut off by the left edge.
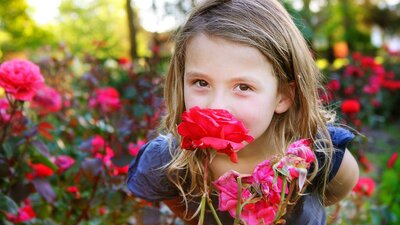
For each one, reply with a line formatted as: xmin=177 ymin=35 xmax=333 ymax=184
xmin=0 ymin=59 xmax=44 ymax=101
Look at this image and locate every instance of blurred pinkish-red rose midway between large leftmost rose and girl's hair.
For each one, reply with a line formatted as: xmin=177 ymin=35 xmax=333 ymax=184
xmin=89 ymin=87 xmax=121 ymax=113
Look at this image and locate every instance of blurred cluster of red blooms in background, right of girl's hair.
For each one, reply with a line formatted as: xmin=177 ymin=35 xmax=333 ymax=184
xmin=321 ymin=52 xmax=400 ymax=129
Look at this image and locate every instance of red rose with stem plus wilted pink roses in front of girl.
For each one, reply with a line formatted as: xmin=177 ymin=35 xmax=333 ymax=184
xmin=177 ymin=107 xmax=315 ymax=225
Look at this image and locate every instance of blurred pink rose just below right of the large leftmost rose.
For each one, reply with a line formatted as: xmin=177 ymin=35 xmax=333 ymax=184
xmin=31 ymin=86 xmax=62 ymax=115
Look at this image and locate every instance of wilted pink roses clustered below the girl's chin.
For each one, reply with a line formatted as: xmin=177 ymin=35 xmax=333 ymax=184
xmin=213 ymin=139 xmax=315 ymax=225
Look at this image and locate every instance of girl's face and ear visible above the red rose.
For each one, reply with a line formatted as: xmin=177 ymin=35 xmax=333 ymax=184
xmin=183 ymin=34 xmax=287 ymax=139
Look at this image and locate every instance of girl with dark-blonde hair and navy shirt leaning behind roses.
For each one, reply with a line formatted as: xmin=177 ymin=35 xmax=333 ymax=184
xmin=127 ymin=0 xmax=358 ymax=224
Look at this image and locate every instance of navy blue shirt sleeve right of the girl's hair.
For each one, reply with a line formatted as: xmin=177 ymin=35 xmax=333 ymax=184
xmin=315 ymin=126 xmax=354 ymax=181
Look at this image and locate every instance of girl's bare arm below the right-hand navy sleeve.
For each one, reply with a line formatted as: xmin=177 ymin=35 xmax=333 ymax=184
xmin=325 ymin=149 xmax=359 ymax=206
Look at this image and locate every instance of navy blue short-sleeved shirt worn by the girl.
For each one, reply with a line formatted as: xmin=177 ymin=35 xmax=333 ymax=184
xmin=127 ymin=126 xmax=354 ymax=225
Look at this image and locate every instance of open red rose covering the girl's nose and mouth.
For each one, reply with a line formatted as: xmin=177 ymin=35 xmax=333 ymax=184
xmin=178 ymin=106 xmax=254 ymax=163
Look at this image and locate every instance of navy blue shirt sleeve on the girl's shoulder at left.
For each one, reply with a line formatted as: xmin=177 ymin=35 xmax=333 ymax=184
xmin=127 ymin=136 xmax=178 ymax=202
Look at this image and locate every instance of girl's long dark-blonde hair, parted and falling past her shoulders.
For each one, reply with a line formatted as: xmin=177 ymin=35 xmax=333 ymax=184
xmin=161 ymin=0 xmax=334 ymax=218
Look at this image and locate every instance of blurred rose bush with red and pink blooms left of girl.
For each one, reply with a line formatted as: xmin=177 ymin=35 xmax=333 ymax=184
xmin=0 ymin=49 xmax=166 ymax=224
